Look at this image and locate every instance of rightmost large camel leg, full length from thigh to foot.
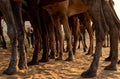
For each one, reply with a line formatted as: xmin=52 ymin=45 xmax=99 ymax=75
xmin=102 ymin=1 xmax=120 ymax=70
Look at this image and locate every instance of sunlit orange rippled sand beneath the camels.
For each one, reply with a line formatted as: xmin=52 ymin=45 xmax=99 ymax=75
xmin=0 ymin=41 xmax=120 ymax=79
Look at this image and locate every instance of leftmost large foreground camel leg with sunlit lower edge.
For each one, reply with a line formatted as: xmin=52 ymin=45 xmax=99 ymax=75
xmin=0 ymin=0 xmax=18 ymax=75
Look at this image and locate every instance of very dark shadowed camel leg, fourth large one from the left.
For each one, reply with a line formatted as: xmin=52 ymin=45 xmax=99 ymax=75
xmin=39 ymin=9 xmax=49 ymax=62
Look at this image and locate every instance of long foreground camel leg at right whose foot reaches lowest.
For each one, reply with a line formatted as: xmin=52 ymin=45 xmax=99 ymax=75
xmin=81 ymin=10 xmax=104 ymax=78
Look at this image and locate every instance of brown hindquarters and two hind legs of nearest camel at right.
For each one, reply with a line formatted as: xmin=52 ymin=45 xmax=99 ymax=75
xmin=81 ymin=0 xmax=119 ymax=78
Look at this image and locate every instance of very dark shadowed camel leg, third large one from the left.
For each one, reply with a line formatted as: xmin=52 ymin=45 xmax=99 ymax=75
xmin=26 ymin=1 xmax=42 ymax=65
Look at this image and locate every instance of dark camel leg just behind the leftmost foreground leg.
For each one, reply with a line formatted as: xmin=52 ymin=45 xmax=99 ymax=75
xmin=12 ymin=2 xmax=27 ymax=69
